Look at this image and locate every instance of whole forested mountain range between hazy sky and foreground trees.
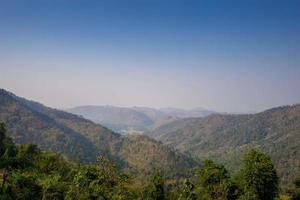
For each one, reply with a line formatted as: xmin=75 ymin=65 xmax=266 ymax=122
xmin=0 ymin=89 xmax=300 ymax=184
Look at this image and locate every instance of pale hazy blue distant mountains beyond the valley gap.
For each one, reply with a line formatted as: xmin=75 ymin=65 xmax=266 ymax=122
xmin=66 ymin=106 xmax=214 ymax=134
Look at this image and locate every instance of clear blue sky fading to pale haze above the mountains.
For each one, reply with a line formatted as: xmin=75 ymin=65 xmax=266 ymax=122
xmin=0 ymin=0 xmax=300 ymax=112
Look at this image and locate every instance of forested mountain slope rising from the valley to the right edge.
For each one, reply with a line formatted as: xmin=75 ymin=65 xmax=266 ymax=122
xmin=148 ymin=105 xmax=300 ymax=183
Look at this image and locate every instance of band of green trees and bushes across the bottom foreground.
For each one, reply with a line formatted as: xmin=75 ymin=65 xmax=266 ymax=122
xmin=0 ymin=124 xmax=300 ymax=200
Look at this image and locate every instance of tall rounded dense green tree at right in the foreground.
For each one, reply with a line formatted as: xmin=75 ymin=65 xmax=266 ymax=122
xmin=239 ymin=149 xmax=279 ymax=200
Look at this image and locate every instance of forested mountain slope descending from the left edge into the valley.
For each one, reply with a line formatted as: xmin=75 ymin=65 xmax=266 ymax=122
xmin=0 ymin=89 xmax=197 ymax=176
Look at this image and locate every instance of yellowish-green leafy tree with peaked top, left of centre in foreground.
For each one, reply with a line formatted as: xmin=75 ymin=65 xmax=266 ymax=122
xmin=66 ymin=157 xmax=131 ymax=200
